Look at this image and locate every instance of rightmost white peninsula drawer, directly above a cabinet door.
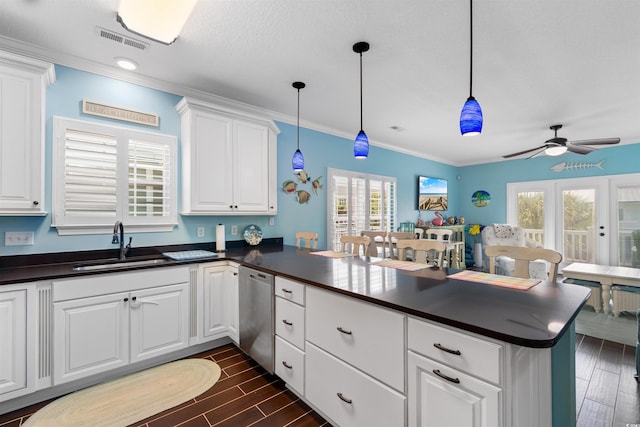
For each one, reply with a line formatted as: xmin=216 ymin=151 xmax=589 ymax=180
xmin=408 ymin=318 xmax=504 ymax=384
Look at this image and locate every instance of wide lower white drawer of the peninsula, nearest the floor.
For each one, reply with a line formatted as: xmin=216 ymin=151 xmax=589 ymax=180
xmin=305 ymin=344 xmax=406 ymax=427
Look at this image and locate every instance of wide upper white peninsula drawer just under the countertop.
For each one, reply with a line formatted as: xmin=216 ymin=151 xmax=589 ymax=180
xmin=306 ymin=286 xmax=405 ymax=391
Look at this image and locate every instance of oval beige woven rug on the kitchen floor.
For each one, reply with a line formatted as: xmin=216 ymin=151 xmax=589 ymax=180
xmin=23 ymin=359 xmax=220 ymax=427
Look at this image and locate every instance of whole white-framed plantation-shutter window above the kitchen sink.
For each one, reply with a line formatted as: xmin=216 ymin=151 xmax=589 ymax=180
xmin=52 ymin=117 xmax=177 ymax=234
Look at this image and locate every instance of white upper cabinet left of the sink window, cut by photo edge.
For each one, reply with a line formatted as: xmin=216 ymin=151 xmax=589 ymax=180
xmin=0 ymin=51 xmax=55 ymax=216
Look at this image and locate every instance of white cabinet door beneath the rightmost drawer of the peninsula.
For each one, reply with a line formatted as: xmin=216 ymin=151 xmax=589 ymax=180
xmin=408 ymin=351 xmax=502 ymax=427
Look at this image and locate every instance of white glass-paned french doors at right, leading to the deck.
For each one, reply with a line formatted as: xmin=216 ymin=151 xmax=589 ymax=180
xmin=507 ymin=174 xmax=640 ymax=266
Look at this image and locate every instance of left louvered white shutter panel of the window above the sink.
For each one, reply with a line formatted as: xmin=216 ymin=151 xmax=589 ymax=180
xmin=64 ymin=129 xmax=118 ymax=219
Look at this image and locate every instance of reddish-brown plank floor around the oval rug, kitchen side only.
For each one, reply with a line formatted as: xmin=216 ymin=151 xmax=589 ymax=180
xmin=0 ymin=344 xmax=331 ymax=427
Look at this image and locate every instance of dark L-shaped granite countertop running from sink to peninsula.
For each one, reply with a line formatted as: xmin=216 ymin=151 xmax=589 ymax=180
xmin=0 ymin=239 xmax=590 ymax=348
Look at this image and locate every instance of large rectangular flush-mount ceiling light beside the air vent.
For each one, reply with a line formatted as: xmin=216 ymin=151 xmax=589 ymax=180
xmin=116 ymin=0 xmax=197 ymax=44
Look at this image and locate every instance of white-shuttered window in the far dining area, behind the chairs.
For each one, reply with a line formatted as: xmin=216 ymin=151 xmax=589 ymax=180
xmin=327 ymin=168 xmax=396 ymax=251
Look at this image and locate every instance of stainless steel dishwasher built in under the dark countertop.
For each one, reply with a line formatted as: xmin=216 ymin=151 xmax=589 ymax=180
xmin=238 ymin=266 xmax=275 ymax=374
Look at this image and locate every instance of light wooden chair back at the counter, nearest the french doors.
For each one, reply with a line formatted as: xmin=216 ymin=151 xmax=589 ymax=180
xmin=484 ymin=246 xmax=562 ymax=283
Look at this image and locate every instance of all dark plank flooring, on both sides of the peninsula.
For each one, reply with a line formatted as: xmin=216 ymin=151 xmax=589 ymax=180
xmin=0 ymin=334 xmax=640 ymax=427
